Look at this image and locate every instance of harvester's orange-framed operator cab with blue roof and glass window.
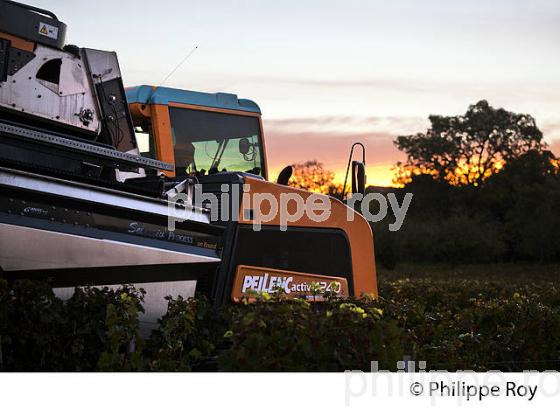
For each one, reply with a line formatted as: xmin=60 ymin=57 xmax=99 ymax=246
xmin=126 ymin=85 xmax=268 ymax=179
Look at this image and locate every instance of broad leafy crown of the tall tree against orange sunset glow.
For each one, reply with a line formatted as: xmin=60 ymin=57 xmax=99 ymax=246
xmin=394 ymin=100 xmax=546 ymax=186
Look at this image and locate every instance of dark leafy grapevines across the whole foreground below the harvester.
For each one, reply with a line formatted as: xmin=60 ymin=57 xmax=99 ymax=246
xmin=0 ymin=265 xmax=560 ymax=371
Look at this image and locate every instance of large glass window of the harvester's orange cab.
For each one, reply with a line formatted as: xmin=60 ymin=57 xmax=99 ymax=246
xmin=169 ymin=107 xmax=263 ymax=175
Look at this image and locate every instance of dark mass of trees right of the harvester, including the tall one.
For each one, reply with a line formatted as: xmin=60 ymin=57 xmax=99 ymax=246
xmin=368 ymin=100 xmax=560 ymax=268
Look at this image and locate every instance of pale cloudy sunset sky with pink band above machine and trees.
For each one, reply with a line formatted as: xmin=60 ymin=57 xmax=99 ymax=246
xmin=36 ymin=0 xmax=560 ymax=185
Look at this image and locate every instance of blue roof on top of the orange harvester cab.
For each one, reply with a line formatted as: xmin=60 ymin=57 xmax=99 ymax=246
xmin=126 ymin=85 xmax=261 ymax=114
